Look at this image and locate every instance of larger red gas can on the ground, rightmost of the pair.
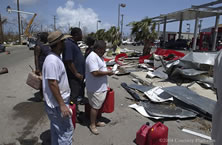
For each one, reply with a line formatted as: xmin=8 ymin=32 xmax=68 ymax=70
xmin=147 ymin=122 xmax=168 ymax=145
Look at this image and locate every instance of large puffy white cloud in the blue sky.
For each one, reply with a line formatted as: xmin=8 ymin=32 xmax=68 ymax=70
xmin=56 ymin=0 xmax=111 ymax=33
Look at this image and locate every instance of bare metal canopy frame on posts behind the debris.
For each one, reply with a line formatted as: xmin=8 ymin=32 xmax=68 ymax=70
xmin=151 ymin=0 xmax=222 ymax=51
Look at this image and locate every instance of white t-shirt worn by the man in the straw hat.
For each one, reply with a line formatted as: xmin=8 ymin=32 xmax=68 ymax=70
xmin=42 ymin=53 xmax=70 ymax=108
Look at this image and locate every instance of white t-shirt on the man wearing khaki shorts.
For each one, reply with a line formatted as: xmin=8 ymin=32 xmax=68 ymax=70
xmin=85 ymin=51 xmax=108 ymax=92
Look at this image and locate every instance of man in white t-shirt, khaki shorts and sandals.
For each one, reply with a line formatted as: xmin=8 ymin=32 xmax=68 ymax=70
xmin=85 ymin=40 xmax=113 ymax=135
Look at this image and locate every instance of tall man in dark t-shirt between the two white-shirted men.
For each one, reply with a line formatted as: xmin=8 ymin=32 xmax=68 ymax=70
xmin=63 ymin=28 xmax=85 ymax=106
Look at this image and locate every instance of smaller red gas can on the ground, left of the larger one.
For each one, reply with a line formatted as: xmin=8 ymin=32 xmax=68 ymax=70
xmin=136 ymin=124 xmax=151 ymax=145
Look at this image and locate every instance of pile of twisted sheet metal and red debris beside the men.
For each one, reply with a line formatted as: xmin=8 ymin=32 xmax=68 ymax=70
xmin=106 ymin=48 xmax=217 ymax=120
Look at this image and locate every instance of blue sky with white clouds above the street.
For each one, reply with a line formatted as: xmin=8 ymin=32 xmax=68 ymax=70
xmin=0 ymin=0 xmax=222 ymax=34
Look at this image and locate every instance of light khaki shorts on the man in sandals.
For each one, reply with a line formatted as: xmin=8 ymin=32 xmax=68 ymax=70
xmin=87 ymin=91 xmax=107 ymax=109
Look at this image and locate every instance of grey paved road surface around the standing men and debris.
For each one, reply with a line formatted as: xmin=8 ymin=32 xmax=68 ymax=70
xmin=0 ymin=47 xmax=214 ymax=145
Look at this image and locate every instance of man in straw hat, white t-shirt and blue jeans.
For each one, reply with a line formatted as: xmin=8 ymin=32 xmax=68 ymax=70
xmin=42 ymin=31 xmax=74 ymax=145
